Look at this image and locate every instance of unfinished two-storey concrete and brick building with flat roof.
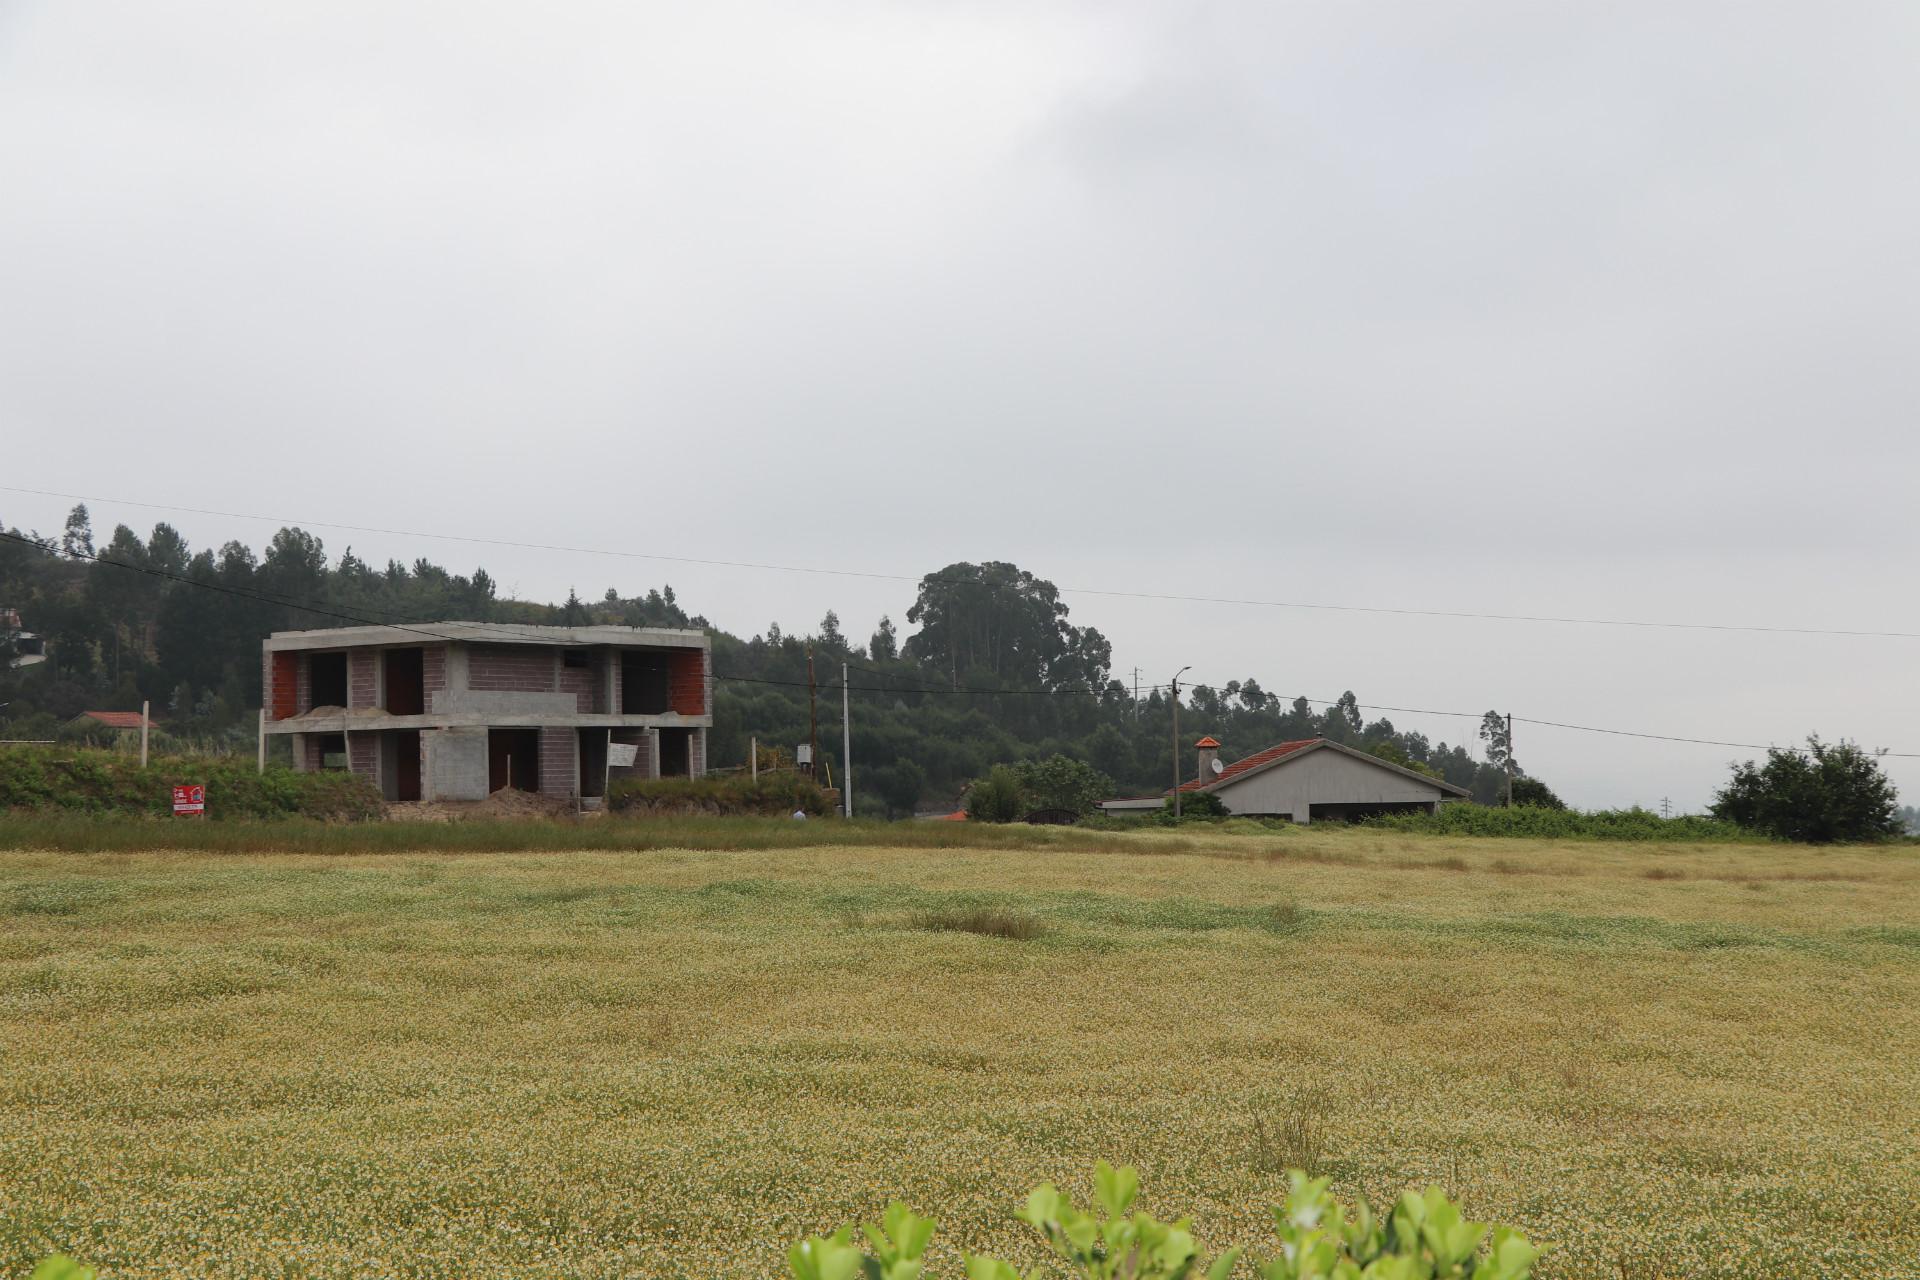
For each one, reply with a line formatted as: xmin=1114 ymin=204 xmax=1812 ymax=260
xmin=261 ymin=622 xmax=712 ymax=808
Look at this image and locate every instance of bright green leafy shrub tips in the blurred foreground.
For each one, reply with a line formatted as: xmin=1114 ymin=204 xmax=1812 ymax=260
xmin=787 ymin=1161 xmax=1540 ymax=1280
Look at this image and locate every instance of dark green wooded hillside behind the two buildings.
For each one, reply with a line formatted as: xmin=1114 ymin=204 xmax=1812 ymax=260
xmin=0 ymin=507 xmax=1551 ymax=816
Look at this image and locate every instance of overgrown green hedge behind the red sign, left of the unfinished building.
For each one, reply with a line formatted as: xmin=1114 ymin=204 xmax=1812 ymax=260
xmin=0 ymin=747 xmax=380 ymax=821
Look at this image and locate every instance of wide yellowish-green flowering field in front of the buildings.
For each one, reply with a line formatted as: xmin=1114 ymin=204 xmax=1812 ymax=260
xmin=0 ymin=831 xmax=1920 ymax=1278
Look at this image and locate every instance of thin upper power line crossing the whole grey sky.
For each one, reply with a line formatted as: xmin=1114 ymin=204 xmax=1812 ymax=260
xmin=0 ymin=486 xmax=1920 ymax=639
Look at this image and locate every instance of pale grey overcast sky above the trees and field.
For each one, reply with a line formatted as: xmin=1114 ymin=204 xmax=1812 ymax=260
xmin=0 ymin=0 xmax=1920 ymax=808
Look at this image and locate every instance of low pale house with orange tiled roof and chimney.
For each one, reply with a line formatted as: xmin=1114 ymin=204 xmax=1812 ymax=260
xmin=1100 ymin=737 xmax=1471 ymax=823
